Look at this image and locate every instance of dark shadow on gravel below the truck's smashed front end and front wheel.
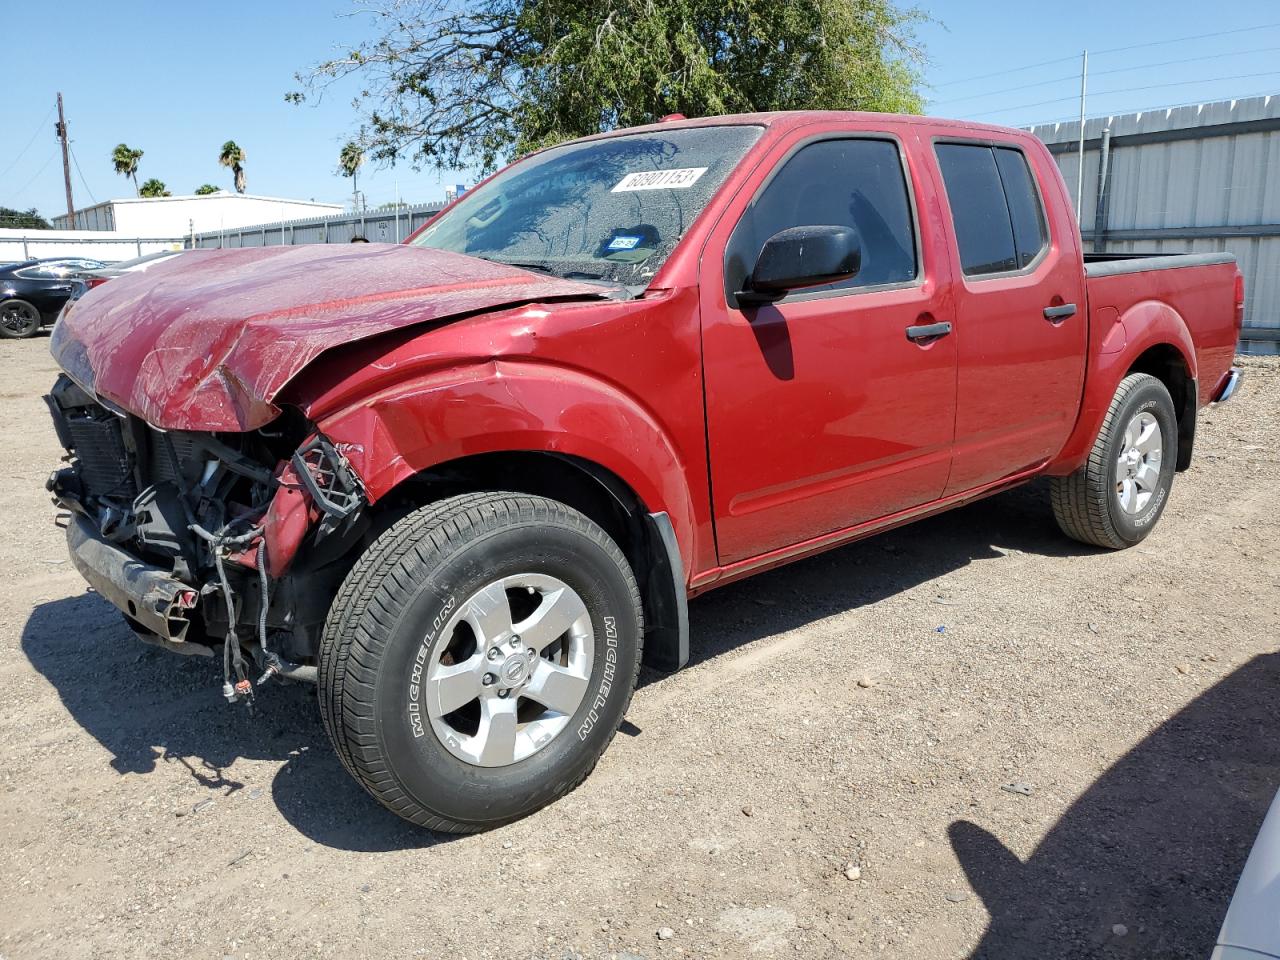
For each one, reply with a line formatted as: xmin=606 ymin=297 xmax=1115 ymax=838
xmin=22 ymin=594 xmax=440 ymax=852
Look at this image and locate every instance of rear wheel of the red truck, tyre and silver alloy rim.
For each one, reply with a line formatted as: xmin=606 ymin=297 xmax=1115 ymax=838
xmin=1050 ymin=374 xmax=1178 ymax=549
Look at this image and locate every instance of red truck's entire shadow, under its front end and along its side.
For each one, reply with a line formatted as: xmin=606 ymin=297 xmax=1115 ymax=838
xmin=22 ymin=488 xmax=1093 ymax=851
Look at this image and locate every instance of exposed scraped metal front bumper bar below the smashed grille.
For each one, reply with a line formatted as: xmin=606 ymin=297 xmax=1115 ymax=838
xmin=67 ymin=513 xmax=200 ymax=643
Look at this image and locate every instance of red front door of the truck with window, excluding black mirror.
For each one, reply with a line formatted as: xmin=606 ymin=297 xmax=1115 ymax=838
xmin=701 ymin=129 xmax=956 ymax=564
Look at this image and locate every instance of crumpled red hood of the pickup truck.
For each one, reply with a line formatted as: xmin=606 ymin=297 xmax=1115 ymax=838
xmin=57 ymin=243 xmax=608 ymax=431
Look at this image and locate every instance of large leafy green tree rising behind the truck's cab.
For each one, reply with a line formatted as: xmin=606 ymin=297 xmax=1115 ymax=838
xmin=285 ymin=0 xmax=925 ymax=170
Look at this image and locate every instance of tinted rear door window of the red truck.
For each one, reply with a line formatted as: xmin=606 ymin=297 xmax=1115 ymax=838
xmin=936 ymin=143 xmax=1048 ymax=276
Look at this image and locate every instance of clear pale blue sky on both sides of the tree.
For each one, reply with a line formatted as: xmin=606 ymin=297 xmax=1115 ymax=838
xmin=0 ymin=0 xmax=1280 ymax=215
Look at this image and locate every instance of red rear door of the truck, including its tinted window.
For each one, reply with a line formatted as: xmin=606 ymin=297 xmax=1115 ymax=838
xmin=933 ymin=140 xmax=1085 ymax=495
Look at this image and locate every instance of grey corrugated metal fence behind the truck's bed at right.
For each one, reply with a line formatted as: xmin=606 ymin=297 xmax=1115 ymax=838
xmin=1030 ymin=96 xmax=1280 ymax=352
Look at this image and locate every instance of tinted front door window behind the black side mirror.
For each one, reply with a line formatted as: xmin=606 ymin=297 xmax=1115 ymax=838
xmin=724 ymin=140 xmax=916 ymax=293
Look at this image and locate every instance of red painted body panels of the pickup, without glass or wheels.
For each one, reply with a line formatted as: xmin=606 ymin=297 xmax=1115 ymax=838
xmin=54 ymin=113 xmax=1239 ymax=593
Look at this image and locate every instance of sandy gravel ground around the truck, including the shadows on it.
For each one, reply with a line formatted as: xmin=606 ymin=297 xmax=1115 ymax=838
xmin=0 ymin=338 xmax=1280 ymax=960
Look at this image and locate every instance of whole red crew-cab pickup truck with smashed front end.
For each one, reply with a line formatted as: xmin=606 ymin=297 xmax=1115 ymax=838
xmin=47 ymin=113 xmax=1244 ymax=832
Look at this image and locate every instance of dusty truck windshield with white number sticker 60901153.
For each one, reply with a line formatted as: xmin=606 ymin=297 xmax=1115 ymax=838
xmin=412 ymin=125 xmax=763 ymax=285
